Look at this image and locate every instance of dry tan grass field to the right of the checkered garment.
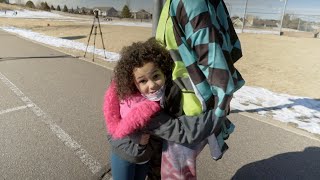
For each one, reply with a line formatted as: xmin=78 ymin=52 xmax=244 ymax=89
xmin=237 ymin=34 xmax=320 ymax=99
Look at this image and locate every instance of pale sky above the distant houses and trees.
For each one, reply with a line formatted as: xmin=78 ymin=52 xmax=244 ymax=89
xmin=9 ymin=0 xmax=320 ymax=15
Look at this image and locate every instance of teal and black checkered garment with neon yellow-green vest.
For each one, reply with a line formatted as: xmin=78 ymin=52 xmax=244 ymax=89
xmin=156 ymin=0 xmax=245 ymax=151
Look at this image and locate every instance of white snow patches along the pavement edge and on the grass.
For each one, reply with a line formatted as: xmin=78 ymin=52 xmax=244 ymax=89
xmin=0 ymin=11 xmax=320 ymax=135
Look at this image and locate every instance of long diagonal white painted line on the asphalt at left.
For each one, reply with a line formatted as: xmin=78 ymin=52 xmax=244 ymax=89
xmin=0 ymin=72 xmax=102 ymax=174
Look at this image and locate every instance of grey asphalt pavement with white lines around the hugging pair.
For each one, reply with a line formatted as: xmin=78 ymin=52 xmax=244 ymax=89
xmin=0 ymin=31 xmax=320 ymax=180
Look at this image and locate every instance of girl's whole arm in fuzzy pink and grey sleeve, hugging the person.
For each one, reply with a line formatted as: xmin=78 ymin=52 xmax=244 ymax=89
xmin=104 ymin=82 xmax=226 ymax=144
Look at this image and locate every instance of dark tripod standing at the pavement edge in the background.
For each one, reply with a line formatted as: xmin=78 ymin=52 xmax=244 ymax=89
xmin=83 ymin=11 xmax=107 ymax=61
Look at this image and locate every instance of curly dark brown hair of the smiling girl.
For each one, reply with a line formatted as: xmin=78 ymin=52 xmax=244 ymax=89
xmin=114 ymin=38 xmax=174 ymax=99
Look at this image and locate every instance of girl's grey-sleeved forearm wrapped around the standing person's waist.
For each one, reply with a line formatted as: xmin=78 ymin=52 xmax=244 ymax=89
xmin=148 ymin=110 xmax=230 ymax=144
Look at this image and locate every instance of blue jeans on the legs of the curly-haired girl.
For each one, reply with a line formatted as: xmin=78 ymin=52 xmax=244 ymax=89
xmin=111 ymin=153 xmax=149 ymax=180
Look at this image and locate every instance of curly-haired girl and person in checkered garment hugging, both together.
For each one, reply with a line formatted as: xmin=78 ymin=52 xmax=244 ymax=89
xmin=103 ymin=0 xmax=244 ymax=180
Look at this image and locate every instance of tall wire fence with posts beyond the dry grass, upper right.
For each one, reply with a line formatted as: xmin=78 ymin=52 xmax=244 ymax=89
xmin=225 ymin=0 xmax=320 ymax=35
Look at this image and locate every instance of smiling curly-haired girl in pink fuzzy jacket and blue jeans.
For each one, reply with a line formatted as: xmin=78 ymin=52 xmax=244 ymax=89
xmin=103 ymin=38 xmax=221 ymax=180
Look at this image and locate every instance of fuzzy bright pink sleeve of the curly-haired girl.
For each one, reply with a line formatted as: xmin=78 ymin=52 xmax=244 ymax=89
xmin=103 ymin=81 xmax=160 ymax=138
